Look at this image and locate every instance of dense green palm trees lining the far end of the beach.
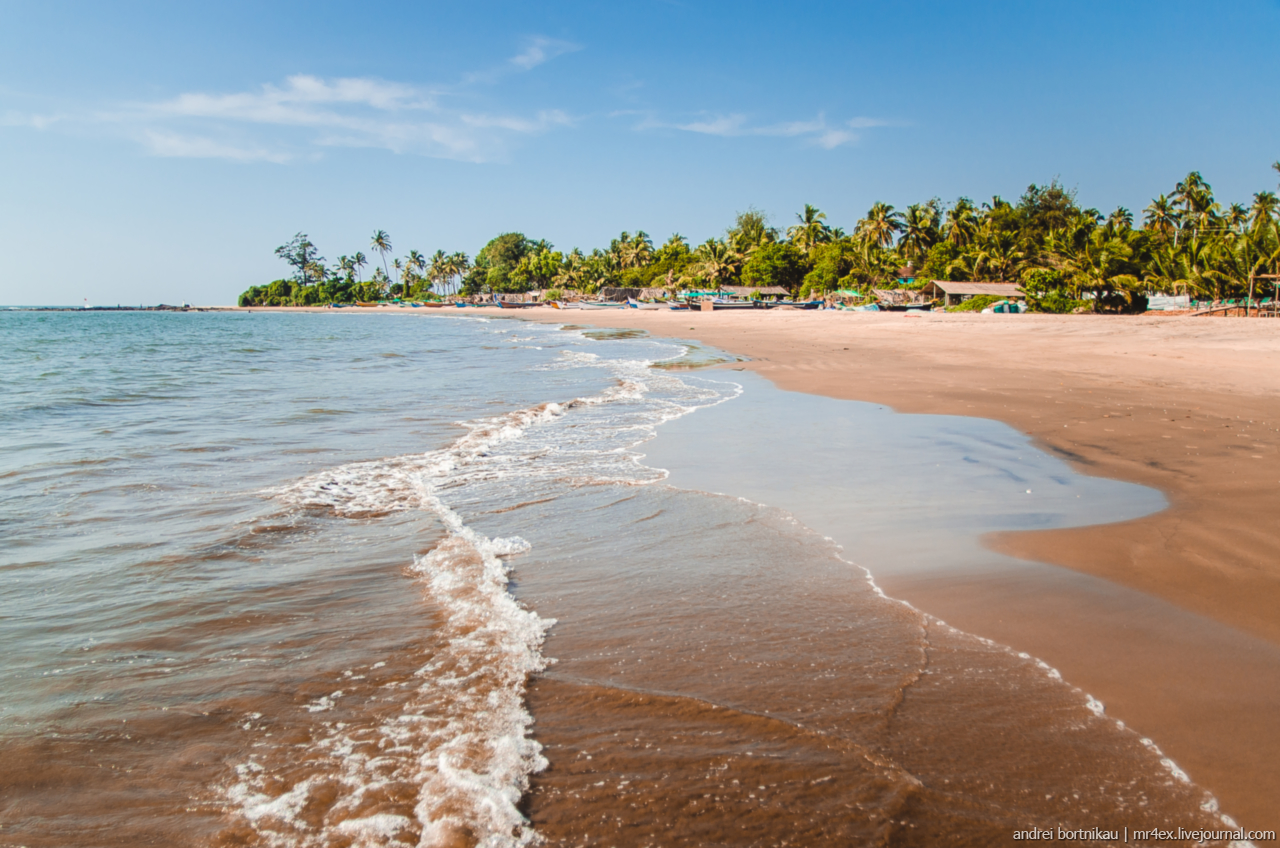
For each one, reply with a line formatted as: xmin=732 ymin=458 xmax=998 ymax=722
xmin=241 ymin=163 xmax=1280 ymax=311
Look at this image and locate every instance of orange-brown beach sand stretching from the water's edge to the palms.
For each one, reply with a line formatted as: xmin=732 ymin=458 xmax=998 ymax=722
xmin=509 ymin=310 xmax=1280 ymax=828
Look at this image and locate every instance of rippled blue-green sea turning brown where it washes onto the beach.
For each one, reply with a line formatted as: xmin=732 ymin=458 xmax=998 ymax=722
xmin=0 ymin=313 xmax=1239 ymax=847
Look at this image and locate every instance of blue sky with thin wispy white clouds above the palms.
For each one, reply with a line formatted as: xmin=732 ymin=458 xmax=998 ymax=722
xmin=0 ymin=0 xmax=1280 ymax=305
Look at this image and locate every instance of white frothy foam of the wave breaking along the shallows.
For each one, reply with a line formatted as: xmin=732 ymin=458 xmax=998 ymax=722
xmin=223 ymin=351 xmax=741 ymax=848
